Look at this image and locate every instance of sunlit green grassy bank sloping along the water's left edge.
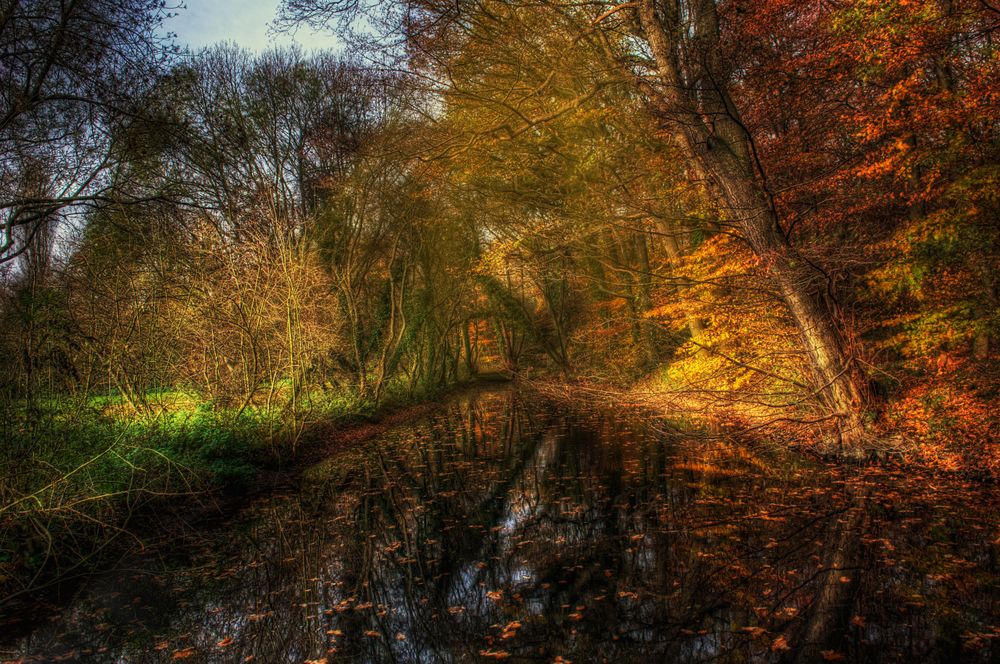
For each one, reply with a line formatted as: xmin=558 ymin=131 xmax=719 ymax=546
xmin=0 ymin=382 xmax=464 ymax=609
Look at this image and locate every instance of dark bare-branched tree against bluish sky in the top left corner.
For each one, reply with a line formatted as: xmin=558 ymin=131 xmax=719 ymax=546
xmin=0 ymin=0 xmax=172 ymax=263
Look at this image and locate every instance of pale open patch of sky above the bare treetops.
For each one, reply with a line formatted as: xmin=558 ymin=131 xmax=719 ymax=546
xmin=164 ymin=0 xmax=337 ymax=51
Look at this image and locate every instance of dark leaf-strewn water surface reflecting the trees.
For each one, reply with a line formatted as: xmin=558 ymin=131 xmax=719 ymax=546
xmin=7 ymin=390 xmax=1000 ymax=662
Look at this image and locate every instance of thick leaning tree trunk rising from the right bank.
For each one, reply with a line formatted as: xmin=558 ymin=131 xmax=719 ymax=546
xmin=637 ymin=0 xmax=865 ymax=454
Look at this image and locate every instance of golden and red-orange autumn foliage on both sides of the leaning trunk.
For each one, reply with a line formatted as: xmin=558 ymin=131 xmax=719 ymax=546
xmin=404 ymin=0 xmax=1000 ymax=472
